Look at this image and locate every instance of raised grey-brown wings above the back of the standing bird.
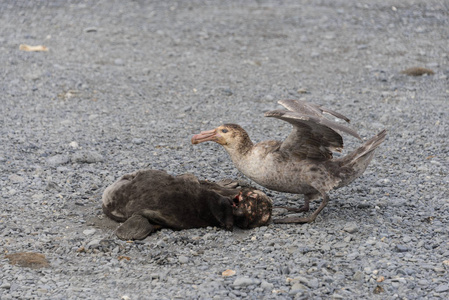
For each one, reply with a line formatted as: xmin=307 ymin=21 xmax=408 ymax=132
xmin=265 ymin=100 xmax=360 ymax=160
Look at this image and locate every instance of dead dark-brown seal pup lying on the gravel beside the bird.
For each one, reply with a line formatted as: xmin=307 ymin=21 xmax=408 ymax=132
xmin=102 ymin=170 xmax=272 ymax=240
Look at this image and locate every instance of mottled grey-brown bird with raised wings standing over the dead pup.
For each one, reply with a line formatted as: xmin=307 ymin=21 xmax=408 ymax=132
xmin=191 ymin=99 xmax=387 ymax=224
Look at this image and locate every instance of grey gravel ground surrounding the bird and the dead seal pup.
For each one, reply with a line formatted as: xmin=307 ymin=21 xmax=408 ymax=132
xmin=0 ymin=0 xmax=449 ymax=300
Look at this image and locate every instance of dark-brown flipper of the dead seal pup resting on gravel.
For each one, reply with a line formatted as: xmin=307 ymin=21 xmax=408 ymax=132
xmin=115 ymin=215 xmax=156 ymax=240
